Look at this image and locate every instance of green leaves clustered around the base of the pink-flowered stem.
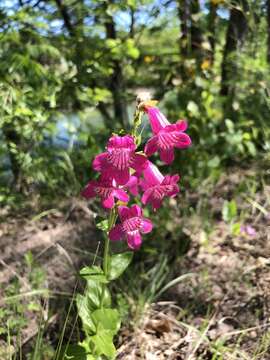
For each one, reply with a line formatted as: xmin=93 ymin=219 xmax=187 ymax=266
xmin=75 ymin=252 xmax=133 ymax=359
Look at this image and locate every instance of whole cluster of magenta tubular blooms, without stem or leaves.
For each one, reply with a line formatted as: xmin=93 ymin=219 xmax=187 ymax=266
xmin=82 ymin=106 xmax=191 ymax=250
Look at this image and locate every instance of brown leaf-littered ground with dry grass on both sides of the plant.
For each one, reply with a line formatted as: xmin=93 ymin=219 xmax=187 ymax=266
xmin=0 ymin=170 xmax=270 ymax=360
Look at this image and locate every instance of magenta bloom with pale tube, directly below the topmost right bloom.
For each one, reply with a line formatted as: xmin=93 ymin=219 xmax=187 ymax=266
xmin=141 ymin=161 xmax=180 ymax=210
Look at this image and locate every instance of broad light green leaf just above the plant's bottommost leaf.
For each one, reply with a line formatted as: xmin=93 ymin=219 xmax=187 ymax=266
xmin=91 ymin=308 xmax=121 ymax=335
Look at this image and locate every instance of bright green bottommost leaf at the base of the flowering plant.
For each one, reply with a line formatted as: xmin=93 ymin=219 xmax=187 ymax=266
xmin=90 ymin=330 xmax=116 ymax=359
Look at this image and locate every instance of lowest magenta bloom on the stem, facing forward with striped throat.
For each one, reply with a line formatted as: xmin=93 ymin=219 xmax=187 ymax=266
xmin=109 ymin=205 xmax=153 ymax=250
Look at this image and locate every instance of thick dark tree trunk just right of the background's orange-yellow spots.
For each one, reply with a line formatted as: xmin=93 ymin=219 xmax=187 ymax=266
xmin=220 ymin=0 xmax=248 ymax=99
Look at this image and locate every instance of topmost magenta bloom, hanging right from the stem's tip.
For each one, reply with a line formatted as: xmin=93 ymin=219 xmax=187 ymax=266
xmin=144 ymin=107 xmax=191 ymax=164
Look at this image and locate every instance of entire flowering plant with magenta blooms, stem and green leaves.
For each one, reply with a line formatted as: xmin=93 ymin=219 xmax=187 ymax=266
xmin=77 ymin=95 xmax=191 ymax=360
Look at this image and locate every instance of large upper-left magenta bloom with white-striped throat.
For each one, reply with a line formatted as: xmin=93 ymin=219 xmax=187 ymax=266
xmin=93 ymin=135 xmax=147 ymax=185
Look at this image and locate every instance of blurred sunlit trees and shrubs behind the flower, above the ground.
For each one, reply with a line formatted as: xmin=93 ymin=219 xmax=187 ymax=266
xmin=0 ymin=0 xmax=270 ymax=204
